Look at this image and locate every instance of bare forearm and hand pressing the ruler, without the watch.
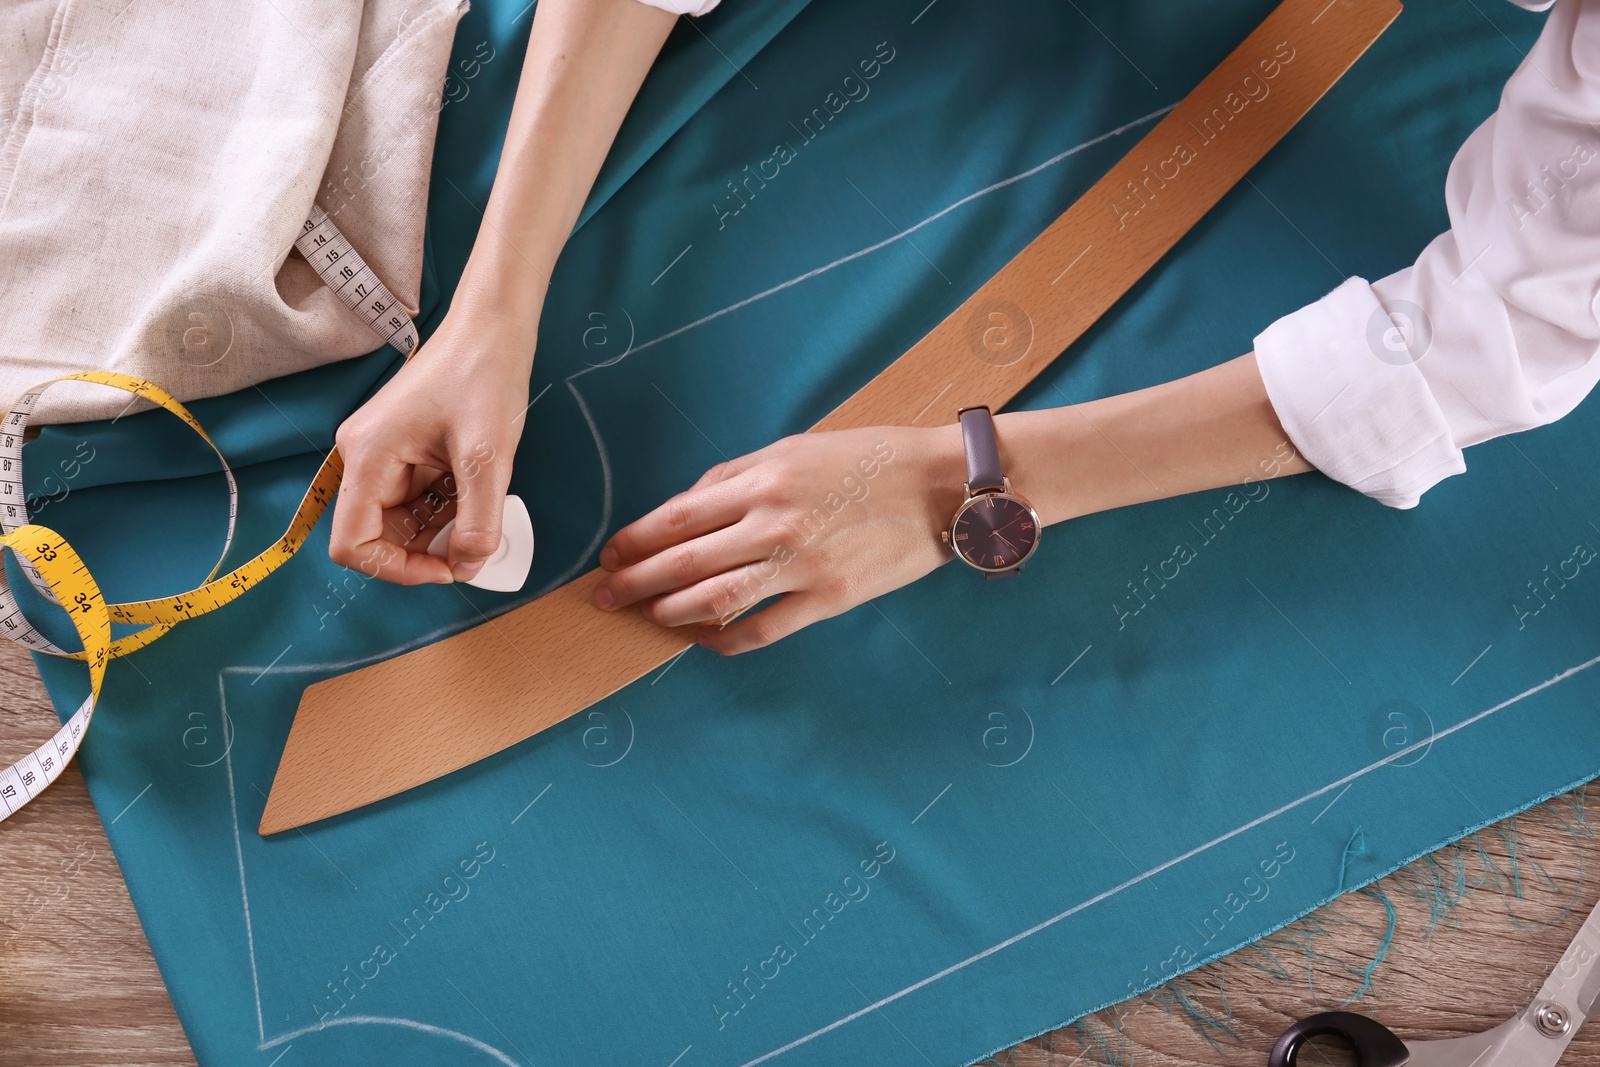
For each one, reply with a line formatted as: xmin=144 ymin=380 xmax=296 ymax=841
xmin=594 ymin=355 xmax=1310 ymax=654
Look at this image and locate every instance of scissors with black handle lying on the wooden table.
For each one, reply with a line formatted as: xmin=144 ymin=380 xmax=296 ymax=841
xmin=1267 ymin=904 xmax=1600 ymax=1067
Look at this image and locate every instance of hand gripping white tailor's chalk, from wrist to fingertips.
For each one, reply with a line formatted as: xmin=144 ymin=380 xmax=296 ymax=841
xmin=328 ymin=302 xmax=538 ymax=585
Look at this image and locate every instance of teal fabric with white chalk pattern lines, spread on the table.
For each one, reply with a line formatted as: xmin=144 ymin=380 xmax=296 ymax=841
xmin=18 ymin=0 xmax=1580 ymax=1067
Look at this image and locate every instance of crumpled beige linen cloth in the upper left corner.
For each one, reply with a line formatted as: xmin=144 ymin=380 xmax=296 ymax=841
xmin=0 ymin=0 xmax=467 ymax=422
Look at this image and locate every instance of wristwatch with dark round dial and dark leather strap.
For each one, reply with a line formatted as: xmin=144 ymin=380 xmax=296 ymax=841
xmin=941 ymin=408 xmax=1040 ymax=577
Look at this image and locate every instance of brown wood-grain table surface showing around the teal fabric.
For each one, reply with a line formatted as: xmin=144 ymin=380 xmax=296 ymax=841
xmin=0 ymin=641 xmax=1600 ymax=1067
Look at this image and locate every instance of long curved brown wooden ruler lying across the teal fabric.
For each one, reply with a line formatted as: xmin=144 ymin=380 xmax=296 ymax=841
xmin=259 ymin=0 xmax=1400 ymax=833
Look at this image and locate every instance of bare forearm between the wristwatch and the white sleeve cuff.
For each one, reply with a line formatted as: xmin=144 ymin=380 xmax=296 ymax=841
xmin=947 ymin=354 xmax=1312 ymax=525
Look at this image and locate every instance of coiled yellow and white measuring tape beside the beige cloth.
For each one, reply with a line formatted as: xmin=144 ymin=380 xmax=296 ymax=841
xmin=0 ymin=205 xmax=418 ymax=822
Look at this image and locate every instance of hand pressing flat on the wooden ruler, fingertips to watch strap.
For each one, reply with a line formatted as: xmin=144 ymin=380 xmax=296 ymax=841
xmin=594 ymin=426 xmax=966 ymax=654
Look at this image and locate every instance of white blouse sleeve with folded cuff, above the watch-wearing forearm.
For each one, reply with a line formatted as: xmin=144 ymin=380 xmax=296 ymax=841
xmin=1256 ymin=0 xmax=1600 ymax=507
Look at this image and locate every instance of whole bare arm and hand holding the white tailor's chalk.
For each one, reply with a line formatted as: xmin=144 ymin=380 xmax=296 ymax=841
xmin=328 ymin=0 xmax=677 ymax=585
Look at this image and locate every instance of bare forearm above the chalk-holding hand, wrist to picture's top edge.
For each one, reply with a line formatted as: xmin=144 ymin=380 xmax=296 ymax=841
xmin=456 ymin=0 xmax=677 ymax=334
